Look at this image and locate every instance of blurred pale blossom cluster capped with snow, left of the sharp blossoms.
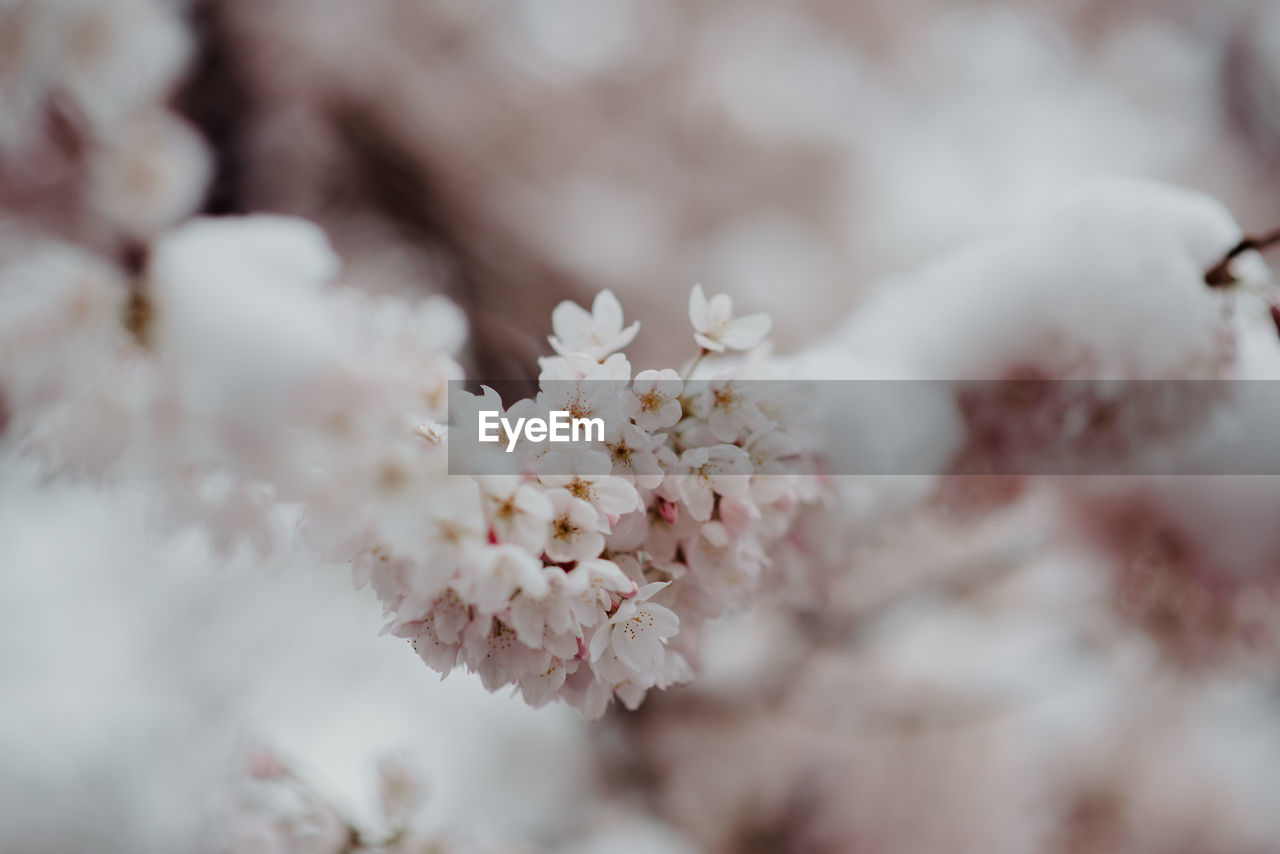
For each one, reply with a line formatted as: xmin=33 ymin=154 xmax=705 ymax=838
xmin=0 ymin=216 xmax=462 ymax=552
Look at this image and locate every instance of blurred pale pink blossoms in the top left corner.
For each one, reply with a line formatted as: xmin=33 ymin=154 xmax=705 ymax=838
xmin=0 ymin=0 xmax=211 ymax=251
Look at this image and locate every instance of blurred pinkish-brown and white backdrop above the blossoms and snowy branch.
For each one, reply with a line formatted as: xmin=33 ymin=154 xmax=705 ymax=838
xmin=180 ymin=0 xmax=1280 ymax=378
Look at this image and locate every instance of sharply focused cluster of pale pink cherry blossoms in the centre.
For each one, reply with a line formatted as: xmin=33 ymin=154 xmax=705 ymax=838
xmin=373 ymin=287 xmax=817 ymax=717
